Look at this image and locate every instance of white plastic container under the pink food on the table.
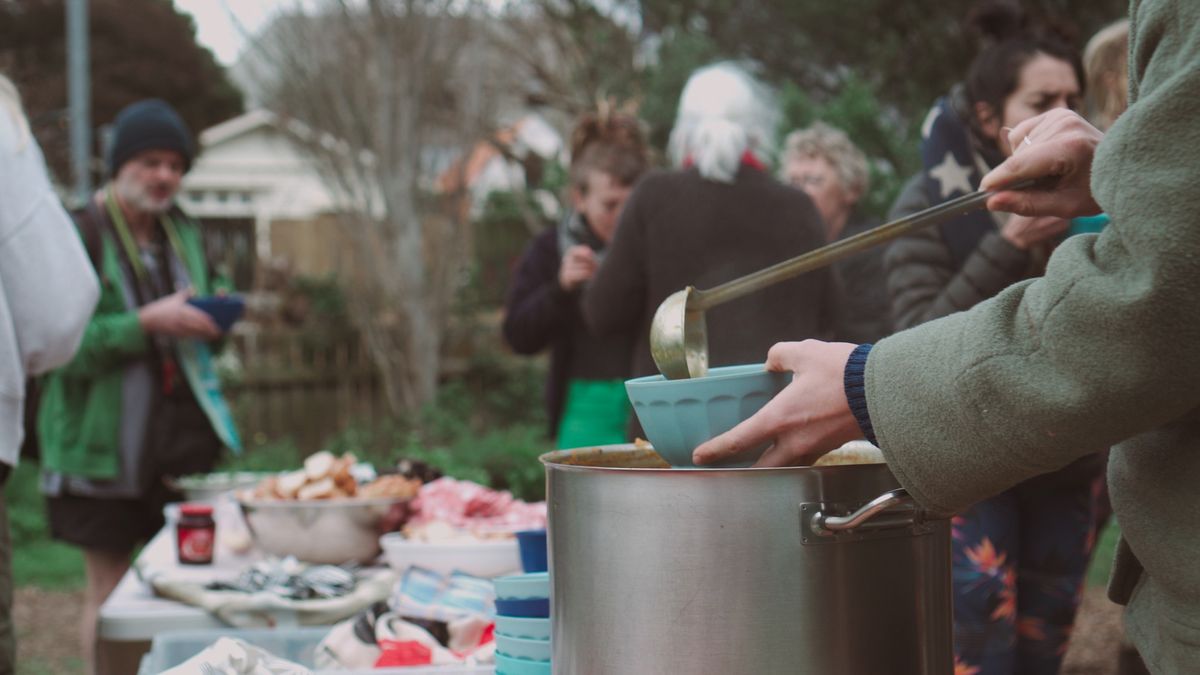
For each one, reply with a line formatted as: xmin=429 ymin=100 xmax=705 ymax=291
xmin=379 ymin=532 xmax=521 ymax=578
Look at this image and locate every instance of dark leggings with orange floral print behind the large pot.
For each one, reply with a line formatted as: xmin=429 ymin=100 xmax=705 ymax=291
xmin=952 ymin=466 xmax=1103 ymax=675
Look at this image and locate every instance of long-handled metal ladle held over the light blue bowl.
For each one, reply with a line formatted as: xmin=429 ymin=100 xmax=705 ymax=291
xmin=650 ymin=181 xmax=1033 ymax=380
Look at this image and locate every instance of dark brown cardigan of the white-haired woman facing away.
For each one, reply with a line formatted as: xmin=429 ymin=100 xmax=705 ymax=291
xmin=583 ymin=167 xmax=839 ymax=376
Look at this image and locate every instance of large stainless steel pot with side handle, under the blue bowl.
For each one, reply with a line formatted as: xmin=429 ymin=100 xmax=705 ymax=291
xmin=541 ymin=446 xmax=953 ymax=675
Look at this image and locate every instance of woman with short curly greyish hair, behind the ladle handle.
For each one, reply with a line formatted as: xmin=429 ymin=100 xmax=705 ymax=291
xmin=779 ymin=121 xmax=892 ymax=342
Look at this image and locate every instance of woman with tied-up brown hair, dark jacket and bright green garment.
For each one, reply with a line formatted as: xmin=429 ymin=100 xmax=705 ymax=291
xmin=503 ymin=109 xmax=648 ymax=448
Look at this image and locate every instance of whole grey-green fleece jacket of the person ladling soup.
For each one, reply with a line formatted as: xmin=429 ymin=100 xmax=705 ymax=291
xmin=865 ymin=0 xmax=1200 ymax=673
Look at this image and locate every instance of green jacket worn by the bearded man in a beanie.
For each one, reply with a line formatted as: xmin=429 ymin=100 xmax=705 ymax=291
xmin=37 ymin=205 xmax=224 ymax=479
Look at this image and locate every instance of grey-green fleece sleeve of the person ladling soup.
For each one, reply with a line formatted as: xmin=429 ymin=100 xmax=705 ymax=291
xmin=865 ymin=14 xmax=1200 ymax=513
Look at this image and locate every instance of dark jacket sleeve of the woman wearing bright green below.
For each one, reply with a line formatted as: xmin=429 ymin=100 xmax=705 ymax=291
xmin=502 ymin=232 xmax=577 ymax=354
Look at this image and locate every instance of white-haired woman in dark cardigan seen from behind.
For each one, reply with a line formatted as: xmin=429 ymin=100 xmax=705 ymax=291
xmin=583 ymin=62 xmax=838 ymax=384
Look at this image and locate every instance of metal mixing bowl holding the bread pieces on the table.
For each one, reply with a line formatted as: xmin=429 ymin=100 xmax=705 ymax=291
xmin=238 ymin=496 xmax=408 ymax=565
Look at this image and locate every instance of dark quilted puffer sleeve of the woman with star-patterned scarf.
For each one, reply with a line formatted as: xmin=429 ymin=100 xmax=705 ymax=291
xmin=883 ymin=174 xmax=1030 ymax=330
